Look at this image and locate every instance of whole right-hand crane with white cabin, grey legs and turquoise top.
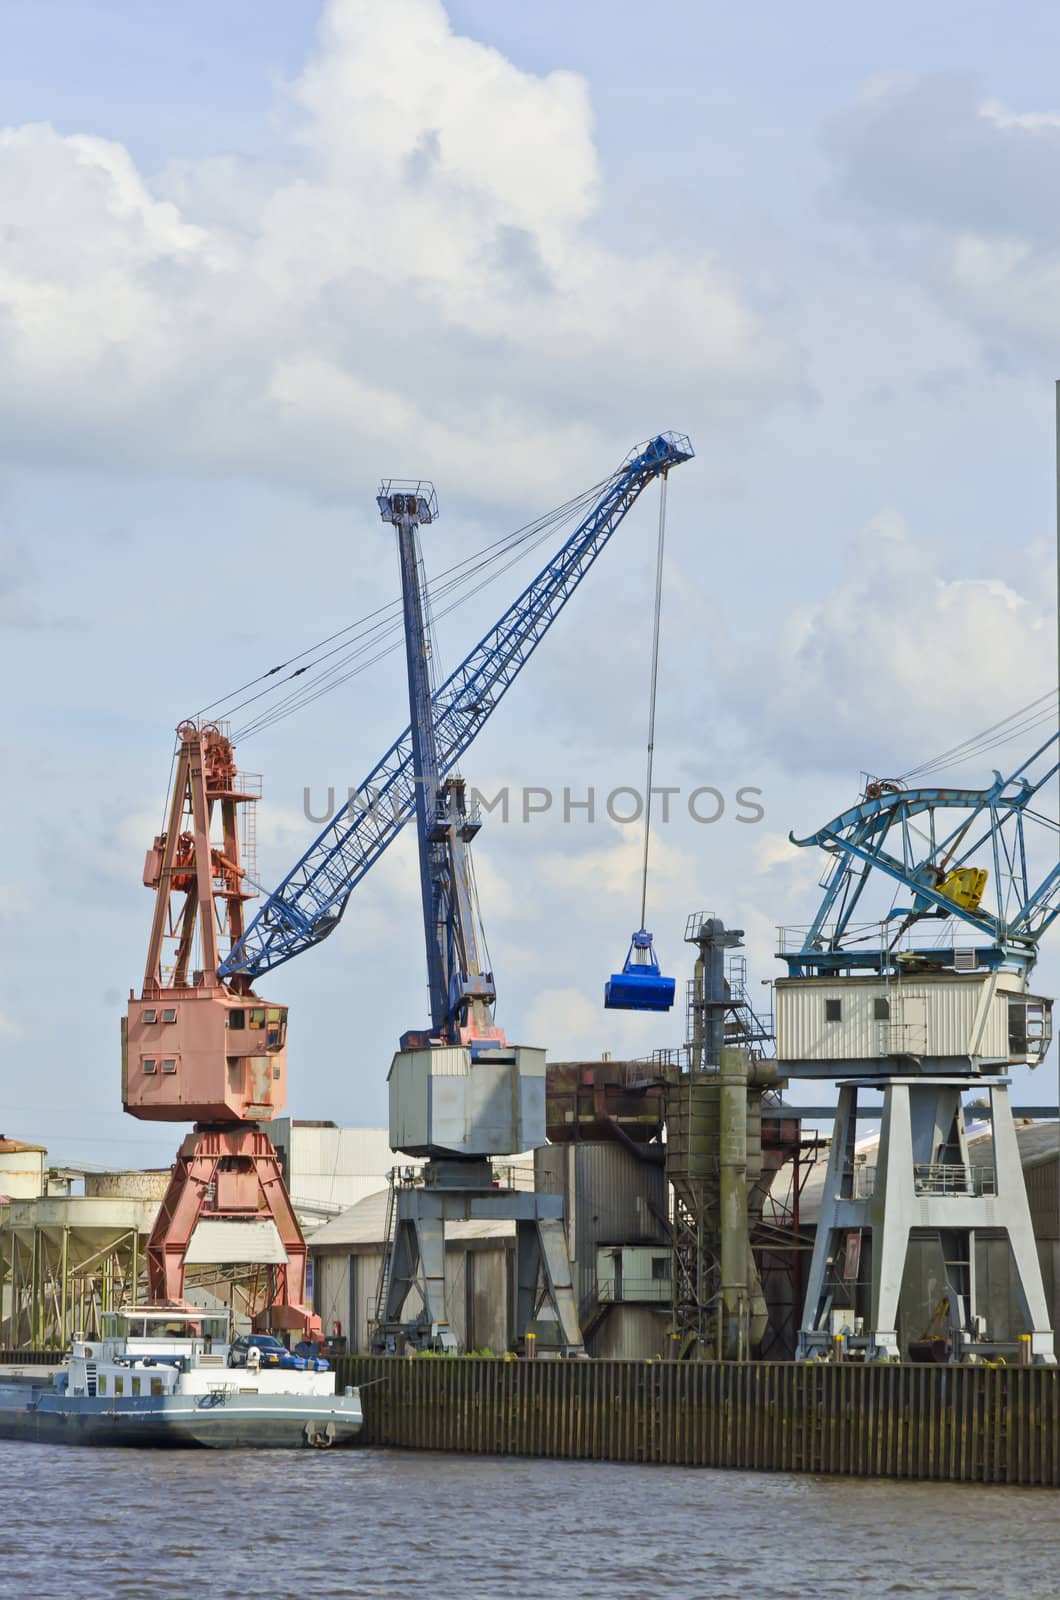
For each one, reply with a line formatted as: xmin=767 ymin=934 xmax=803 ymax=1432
xmin=775 ymin=734 xmax=1060 ymax=1363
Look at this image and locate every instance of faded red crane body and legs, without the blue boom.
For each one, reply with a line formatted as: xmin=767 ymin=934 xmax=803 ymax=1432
xmin=122 ymin=722 xmax=320 ymax=1338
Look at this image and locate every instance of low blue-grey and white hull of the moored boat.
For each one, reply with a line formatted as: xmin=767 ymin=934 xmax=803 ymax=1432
xmin=0 ymin=1389 xmax=362 ymax=1450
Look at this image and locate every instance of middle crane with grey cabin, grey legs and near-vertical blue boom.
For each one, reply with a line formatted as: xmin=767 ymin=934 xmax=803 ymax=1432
xmin=375 ymin=480 xmax=581 ymax=1354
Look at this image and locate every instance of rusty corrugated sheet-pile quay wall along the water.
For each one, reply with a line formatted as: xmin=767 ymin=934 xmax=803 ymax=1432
xmin=336 ymin=1357 xmax=1060 ymax=1488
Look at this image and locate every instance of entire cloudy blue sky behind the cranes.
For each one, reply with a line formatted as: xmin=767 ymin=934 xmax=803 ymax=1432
xmin=0 ymin=0 xmax=1060 ymax=1165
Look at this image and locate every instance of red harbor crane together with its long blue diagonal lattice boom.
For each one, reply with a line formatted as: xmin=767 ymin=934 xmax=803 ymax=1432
xmin=122 ymin=434 xmax=693 ymax=1333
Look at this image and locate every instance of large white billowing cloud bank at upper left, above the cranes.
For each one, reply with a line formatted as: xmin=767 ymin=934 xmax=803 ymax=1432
xmin=0 ymin=0 xmax=799 ymax=504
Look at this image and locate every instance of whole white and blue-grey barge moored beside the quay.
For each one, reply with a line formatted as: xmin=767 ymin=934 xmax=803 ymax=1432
xmin=0 ymin=1306 xmax=363 ymax=1450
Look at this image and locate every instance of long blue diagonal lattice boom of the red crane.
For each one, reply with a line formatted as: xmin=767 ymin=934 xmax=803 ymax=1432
xmin=218 ymin=432 xmax=693 ymax=981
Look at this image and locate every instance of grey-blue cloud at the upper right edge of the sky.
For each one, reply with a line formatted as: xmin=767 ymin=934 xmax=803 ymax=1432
xmin=826 ymin=77 xmax=1060 ymax=360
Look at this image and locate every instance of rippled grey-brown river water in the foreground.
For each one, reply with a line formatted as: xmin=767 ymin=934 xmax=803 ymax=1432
xmin=0 ymin=1442 xmax=1060 ymax=1600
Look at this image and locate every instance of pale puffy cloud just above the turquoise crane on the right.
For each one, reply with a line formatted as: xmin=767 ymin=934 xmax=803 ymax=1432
xmin=730 ymin=512 xmax=1055 ymax=776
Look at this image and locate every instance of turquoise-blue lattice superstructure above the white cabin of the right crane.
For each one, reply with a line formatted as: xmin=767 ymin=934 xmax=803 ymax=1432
xmin=781 ymin=734 xmax=1060 ymax=978
